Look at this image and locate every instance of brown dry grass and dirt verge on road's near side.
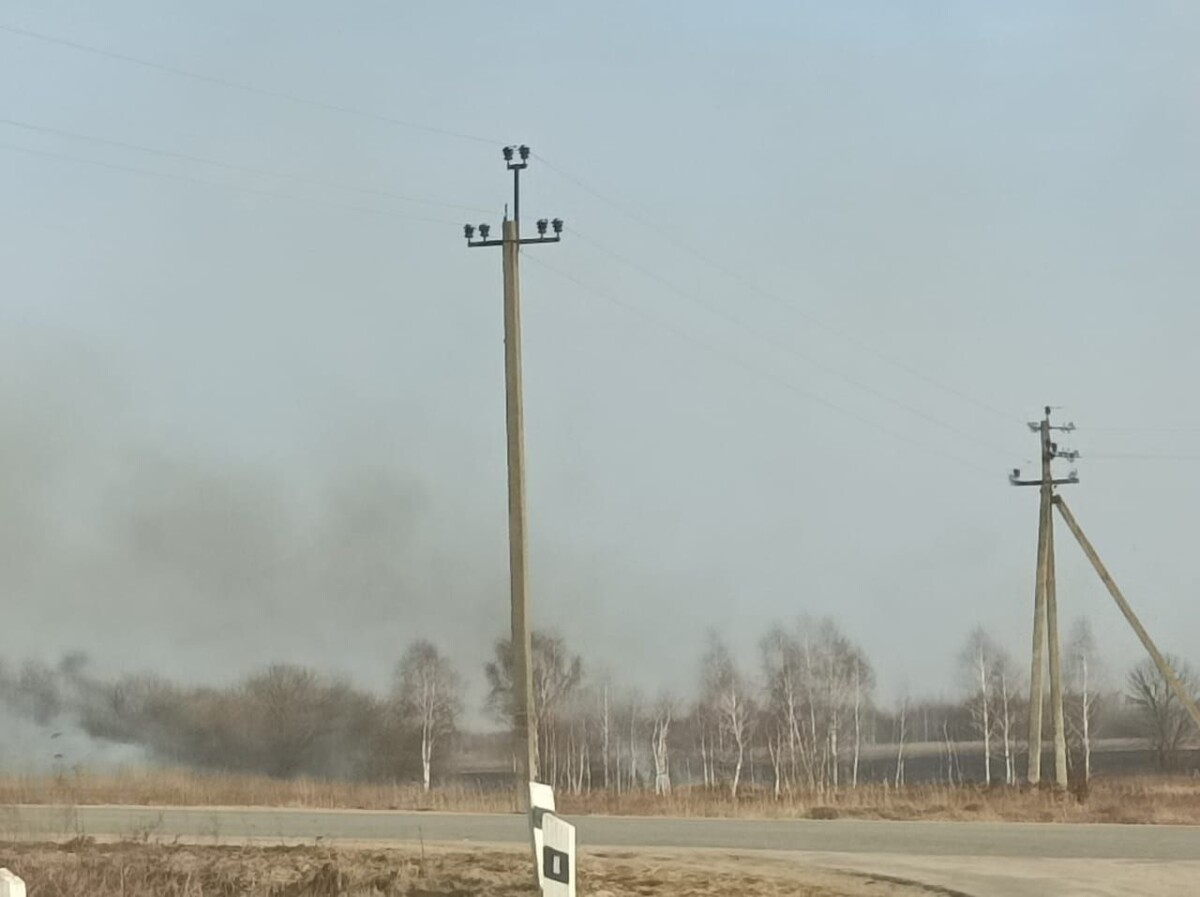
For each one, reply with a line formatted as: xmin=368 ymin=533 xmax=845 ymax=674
xmin=0 ymin=838 xmax=948 ymax=897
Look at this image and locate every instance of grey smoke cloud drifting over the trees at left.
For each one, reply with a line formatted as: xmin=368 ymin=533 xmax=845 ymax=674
xmin=0 ymin=340 xmax=503 ymax=773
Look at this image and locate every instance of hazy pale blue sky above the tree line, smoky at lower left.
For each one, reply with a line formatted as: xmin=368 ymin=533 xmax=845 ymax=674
xmin=0 ymin=0 xmax=1200 ymax=724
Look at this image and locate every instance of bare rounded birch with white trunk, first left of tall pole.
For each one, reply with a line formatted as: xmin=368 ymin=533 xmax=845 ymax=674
xmin=392 ymin=640 xmax=462 ymax=791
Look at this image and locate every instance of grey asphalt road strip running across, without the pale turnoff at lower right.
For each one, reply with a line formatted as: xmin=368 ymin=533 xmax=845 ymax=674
xmin=0 ymin=806 xmax=1200 ymax=861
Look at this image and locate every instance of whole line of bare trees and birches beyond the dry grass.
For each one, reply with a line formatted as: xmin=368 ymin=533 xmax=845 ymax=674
xmin=0 ymin=616 xmax=1200 ymax=799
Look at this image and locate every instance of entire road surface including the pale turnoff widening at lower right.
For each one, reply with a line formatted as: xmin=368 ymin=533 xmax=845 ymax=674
xmin=0 ymin=806 xmax=1200 ymax=897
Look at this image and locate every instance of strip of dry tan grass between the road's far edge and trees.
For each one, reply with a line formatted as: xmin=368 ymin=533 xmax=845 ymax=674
xmin=0 ymin=770 xmax=1200 ymax=824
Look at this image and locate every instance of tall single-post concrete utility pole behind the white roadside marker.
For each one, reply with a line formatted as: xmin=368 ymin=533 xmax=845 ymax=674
xmin=462 ymin=145 xmax=563 ymax=805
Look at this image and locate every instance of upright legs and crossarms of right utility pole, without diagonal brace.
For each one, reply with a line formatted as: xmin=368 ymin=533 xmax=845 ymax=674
xmin=1009 ymin=405 xmax=1079 ymax=788
